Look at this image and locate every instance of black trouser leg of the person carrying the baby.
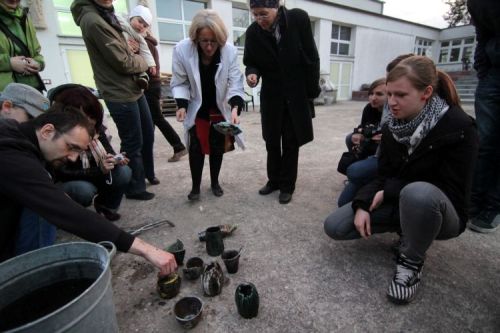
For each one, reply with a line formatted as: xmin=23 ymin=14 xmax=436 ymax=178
xmin=144 ymin=82 xmax=185 ymax=153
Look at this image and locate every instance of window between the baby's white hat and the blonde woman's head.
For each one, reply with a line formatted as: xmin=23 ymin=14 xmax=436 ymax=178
xmin=156 ymin=0 xmax=207 ymax=42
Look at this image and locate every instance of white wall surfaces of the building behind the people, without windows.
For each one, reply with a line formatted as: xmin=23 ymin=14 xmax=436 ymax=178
xmin=31 ymin=0 xmax=475 ymax=101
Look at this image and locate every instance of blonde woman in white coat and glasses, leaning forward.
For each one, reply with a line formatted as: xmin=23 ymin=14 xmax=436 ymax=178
xmin=171 ymin=10 xmax=244 ymax=201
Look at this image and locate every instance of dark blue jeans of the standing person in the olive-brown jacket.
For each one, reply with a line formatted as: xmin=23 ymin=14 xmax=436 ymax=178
xmin=105 ymin=95 xmax=155 ymax=194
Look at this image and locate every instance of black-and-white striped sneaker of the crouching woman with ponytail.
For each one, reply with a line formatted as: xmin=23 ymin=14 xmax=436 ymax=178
xmin=387 ymin=254 xmax=424 ymax=304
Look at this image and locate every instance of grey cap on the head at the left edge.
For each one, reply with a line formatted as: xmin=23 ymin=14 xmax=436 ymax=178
xmin=0 ymin=83 xmax=49 ymax=117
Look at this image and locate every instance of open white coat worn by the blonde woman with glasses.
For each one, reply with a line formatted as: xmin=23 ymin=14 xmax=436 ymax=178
xmin=170 ymin=39 xmax=245 ymax=149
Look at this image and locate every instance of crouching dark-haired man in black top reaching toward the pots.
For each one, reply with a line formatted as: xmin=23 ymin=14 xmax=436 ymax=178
xmin=0 ymin=105 xmax=176 ymax=274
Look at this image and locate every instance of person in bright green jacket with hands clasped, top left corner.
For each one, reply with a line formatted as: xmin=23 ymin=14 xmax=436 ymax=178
xmin=0 ymin=0 xmax=45 ymax=92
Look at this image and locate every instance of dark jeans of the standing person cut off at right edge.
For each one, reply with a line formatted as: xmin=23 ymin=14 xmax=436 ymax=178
xmin=471 ymin=68 xmax=500 ymax=216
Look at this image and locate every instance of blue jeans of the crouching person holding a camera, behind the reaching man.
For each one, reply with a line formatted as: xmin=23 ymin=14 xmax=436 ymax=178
xmin=60 ymin=165 xmax=132 ymax=210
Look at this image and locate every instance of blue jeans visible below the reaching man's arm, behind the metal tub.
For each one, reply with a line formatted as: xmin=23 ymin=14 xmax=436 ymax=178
xmin=15 ymin=208 xmax=56 ymax=256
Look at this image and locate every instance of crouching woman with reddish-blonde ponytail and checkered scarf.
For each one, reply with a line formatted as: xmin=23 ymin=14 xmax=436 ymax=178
xmin=324 ymin=56 xmax=478 ymax=304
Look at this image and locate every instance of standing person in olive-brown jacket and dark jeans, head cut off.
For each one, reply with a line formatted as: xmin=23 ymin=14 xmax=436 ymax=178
xmin=71 ymin=0 xmax=157 ymax=200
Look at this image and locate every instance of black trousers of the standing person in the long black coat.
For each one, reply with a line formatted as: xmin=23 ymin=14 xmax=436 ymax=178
xmin=266 ymin=112 xmax=299 ymax=193
